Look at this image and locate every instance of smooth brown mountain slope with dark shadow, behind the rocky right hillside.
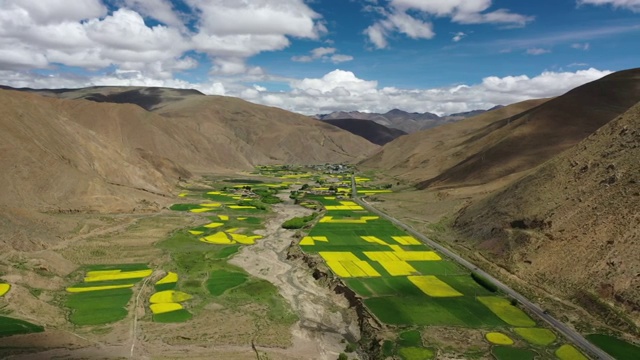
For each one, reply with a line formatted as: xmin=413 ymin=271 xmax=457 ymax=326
xmin=363 ymin=69 xmax=640 ymax=189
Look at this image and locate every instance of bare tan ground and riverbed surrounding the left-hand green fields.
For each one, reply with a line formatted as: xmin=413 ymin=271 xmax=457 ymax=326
xmin=0 ymin=179 xmax=359 ymax=360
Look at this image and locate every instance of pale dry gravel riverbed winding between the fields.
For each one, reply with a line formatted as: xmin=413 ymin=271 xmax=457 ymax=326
xmin=229 ymin=193 xmax=359 ymax=360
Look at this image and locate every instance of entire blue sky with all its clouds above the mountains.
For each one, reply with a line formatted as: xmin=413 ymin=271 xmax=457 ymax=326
xmin=0 ymin=0 xmax=640 ymax=114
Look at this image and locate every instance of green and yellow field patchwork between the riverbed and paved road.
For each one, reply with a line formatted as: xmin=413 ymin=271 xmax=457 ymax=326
xmin=288 ymin=169 xmax=579 ymax=360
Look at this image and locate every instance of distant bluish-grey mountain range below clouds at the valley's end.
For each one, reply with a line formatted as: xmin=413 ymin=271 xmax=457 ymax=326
xmin=315 ymin=105 xmax=502 ymax=133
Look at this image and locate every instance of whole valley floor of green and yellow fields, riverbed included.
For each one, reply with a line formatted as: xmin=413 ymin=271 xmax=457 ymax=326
xmin=0 ymin=166 xmax=637 ymax=360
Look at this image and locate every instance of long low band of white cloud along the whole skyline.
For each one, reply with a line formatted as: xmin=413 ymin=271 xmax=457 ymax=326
xmin=0 ymin=68 xmax=611 ymax=115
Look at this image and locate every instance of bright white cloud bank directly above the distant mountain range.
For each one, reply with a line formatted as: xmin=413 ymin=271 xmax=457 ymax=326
xmin=251 ymin=68 xmax=611 ymax=115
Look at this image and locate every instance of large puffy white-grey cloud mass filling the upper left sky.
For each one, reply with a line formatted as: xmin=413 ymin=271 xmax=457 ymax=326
xmin=0 ymin=0 xmax=324 ymax=78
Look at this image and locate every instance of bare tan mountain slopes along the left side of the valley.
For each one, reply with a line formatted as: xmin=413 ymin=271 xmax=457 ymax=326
xmin=0 ymin=88 xmax=376 ymax=211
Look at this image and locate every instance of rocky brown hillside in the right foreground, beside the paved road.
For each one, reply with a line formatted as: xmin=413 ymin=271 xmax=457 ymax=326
xmin=455 ymin=101 xmax=640 ymax=332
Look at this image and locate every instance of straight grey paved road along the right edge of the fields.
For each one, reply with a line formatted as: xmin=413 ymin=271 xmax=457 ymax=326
xmin=351 ymin=176 xmax=614 ymax=360
